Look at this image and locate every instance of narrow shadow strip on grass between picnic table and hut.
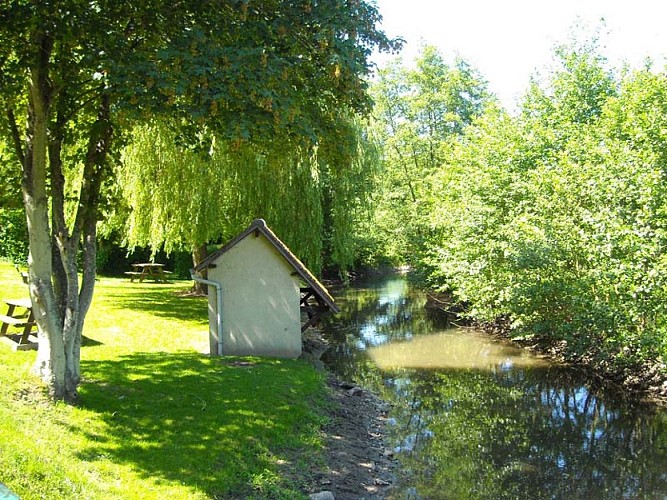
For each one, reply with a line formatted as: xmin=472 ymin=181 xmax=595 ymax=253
xmin=107 ymin=288 xmax=208 ymax=324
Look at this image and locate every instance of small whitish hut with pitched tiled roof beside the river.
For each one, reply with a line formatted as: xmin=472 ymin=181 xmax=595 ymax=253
xmin=192 ymin=219 xmax=338 ymax=358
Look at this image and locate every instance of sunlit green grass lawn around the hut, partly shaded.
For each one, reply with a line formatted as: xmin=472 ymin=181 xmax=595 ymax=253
xmin=0 ymin=262 xmax=328 ymax=499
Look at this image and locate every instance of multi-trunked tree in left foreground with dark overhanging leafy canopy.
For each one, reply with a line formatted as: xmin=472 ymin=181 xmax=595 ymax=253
xmin=0 ymin=0 xmax=392 ymax=401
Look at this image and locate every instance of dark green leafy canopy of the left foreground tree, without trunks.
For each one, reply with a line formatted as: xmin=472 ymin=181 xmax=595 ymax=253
xmin=0 ymin=0 xmax=399 ymax=145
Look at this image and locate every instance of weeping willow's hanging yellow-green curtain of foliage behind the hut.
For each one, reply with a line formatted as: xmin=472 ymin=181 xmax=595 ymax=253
xmin=119 ymin=116 xmax=378 ymax=286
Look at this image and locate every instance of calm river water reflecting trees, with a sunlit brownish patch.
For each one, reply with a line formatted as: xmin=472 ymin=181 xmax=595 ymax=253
xmin=322 ymin=277 xmax=667 ymax=499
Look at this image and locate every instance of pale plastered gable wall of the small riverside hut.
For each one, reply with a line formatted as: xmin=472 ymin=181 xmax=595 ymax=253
xmin=208 ymin=234 xmax=301 ymax=358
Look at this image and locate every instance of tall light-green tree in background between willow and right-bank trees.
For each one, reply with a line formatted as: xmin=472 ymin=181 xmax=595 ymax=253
xmin=371 ymin=46 xmax=493 ymax=263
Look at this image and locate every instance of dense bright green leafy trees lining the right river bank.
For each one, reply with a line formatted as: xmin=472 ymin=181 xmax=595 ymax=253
xmin=421 ymin=39 xmax=667 ymax=369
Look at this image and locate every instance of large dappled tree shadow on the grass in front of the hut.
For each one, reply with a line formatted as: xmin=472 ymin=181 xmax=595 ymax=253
xmin=73 ymin=353 xmax=318 ymax=498
